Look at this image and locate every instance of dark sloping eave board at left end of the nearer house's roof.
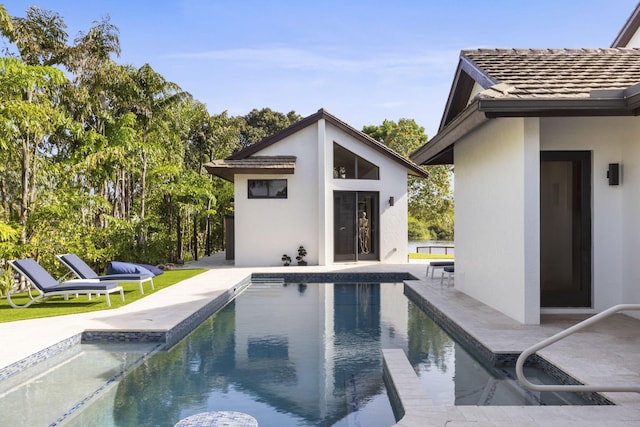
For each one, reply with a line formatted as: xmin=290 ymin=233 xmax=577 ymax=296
xmin=410 ymin=100 xmax=488 ymax=165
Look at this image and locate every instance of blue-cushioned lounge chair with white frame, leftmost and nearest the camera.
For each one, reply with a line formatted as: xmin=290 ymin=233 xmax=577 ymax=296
xmin=7 ymin=258 xmax=124 ymax=308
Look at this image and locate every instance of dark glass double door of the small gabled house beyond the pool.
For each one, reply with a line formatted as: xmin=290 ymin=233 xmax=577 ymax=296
xmin=333 ymin=191 xmax=379 ymax=261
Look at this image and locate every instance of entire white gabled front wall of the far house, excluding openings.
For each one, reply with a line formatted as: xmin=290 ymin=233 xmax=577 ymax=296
xmin=234 ymin=120 xmax=408 ymax=266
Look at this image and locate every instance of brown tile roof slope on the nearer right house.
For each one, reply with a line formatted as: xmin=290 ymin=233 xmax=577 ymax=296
xmin=461 ymin=48 xmax=640 ymax=99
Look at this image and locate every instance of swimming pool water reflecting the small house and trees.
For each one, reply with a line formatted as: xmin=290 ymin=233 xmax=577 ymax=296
xmin=0 ymin=283 xmax=596 ymax=426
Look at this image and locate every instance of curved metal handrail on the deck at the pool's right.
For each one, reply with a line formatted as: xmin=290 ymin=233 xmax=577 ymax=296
xmin=516 ymin=304 xmax=640 ymax=393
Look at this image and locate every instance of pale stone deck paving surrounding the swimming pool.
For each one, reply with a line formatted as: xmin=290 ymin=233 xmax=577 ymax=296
xmin=0 ymin=254 xmax=640 ymax=427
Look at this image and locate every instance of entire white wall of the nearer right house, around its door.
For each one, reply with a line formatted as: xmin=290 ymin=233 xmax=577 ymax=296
xmin=455 ymin=117 xmax=640 ymax=324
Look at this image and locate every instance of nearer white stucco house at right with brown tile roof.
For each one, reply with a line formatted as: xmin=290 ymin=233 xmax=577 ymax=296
xmin=411 ymin=4 xmax=640 ymax=324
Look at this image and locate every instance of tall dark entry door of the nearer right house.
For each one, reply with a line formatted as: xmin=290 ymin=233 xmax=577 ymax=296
xmin=540 ymin=151 xmax=592 ymax=307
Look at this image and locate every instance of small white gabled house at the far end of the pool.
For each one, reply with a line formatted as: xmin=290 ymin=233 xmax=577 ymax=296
xmin=205 ymin=109 xmax=427 ymax=266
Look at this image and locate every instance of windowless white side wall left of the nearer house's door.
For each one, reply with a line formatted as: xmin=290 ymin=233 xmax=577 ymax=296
xmin=454 ymin=118 xmax=540 ymax=324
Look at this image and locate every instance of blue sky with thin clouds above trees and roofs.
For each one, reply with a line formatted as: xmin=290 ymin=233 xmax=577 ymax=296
xmin=0 ymin=0 xmax=637 ymax=136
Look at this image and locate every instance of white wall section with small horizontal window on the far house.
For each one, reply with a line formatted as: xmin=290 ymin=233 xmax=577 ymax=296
xmin=234 ymin=126 xmax=319 ymax=266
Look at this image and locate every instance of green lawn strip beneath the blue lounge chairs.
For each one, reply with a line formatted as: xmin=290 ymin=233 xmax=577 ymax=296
xmin=0 ymin=268 xmax=206 ymax=323
